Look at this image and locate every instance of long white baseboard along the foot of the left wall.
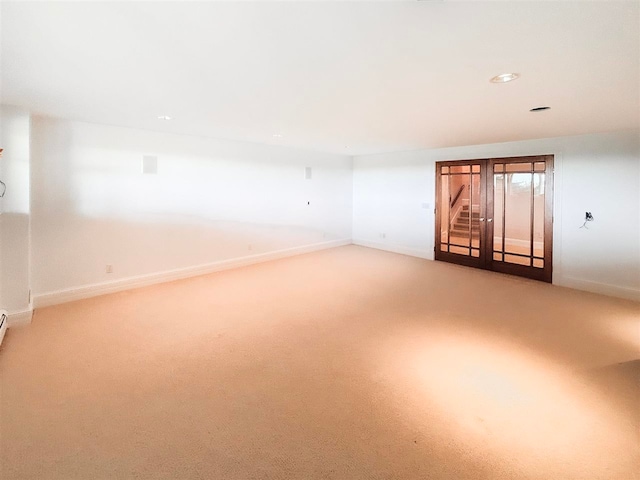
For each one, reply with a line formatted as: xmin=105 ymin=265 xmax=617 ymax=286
xmin=33 ymin=239 xmax=351 ymax=308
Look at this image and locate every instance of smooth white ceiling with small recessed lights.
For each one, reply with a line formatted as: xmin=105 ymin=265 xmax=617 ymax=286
xmin=0 ymin=1 xmax=640 ymax=155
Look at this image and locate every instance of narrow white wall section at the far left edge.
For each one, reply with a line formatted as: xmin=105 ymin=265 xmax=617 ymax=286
xmin=0 ymin=106 xmax=31 ymax=320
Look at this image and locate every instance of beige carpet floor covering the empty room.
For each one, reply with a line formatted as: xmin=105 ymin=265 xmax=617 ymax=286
xmin=0 ymin=246 xmax=640 ymax=480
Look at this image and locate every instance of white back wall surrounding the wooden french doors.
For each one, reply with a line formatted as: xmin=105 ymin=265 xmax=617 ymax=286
xmin=353 ymin=131 xmax=640 ymax=300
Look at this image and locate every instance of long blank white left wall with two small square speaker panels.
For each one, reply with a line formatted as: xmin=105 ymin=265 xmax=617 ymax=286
xmin=31 ymin=117 xmax=352 ymax=306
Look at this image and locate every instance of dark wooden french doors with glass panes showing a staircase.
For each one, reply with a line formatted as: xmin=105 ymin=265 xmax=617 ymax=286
xmin=435 ymin=155 xmax=553 ymax=282
